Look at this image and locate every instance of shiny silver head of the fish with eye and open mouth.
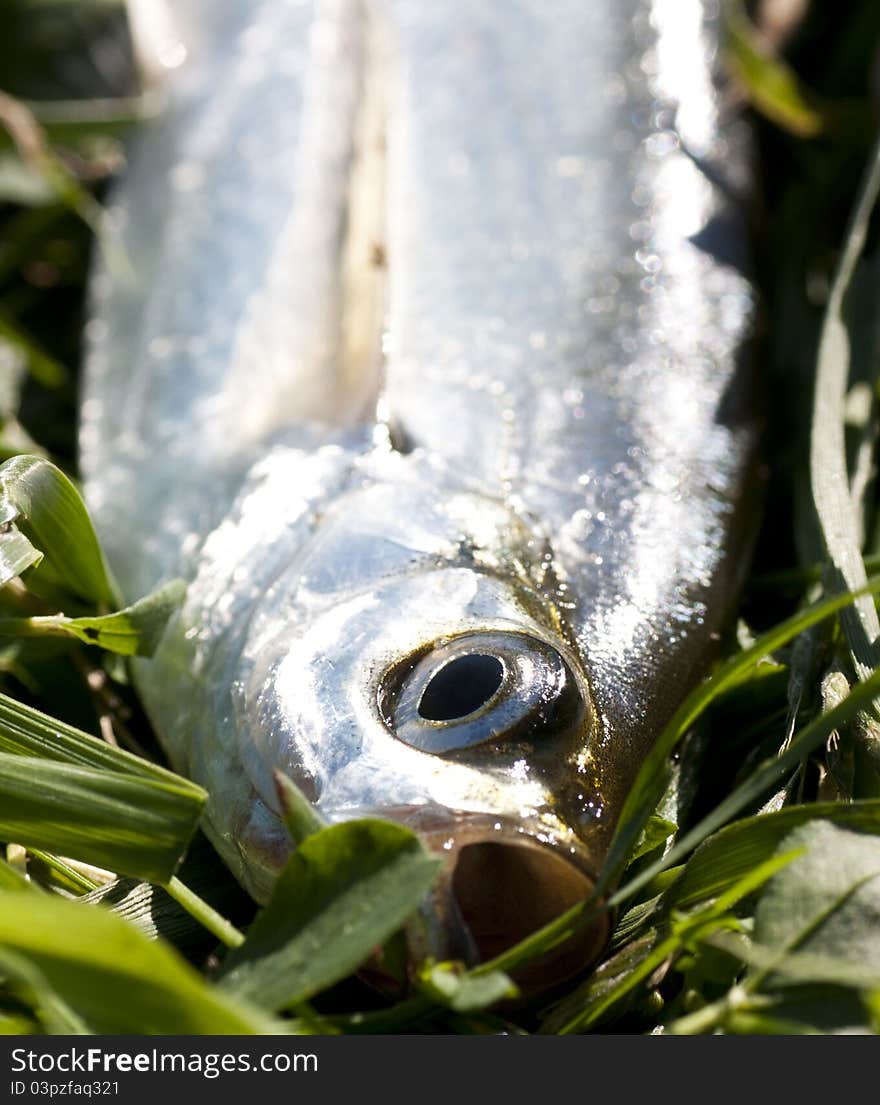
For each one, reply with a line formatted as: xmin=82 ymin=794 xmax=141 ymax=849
xmin=237 ymin=453 xmax=606 ymax=980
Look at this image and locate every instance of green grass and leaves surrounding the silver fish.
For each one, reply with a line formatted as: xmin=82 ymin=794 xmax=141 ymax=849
xmin=0 ymin=0 xmax=880 ymax=1034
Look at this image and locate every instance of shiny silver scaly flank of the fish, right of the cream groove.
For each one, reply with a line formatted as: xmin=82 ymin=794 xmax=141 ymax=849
xmin=386 ymin=0 xmax=754 ymax=835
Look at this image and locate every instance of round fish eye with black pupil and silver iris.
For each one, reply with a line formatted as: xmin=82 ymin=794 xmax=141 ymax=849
xmin=379 ymin=632 xmax=585 ymax=756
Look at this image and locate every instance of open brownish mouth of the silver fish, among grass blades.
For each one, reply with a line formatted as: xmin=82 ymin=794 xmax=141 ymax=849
xmin=380 ymin=807 xmax=610 ymax=996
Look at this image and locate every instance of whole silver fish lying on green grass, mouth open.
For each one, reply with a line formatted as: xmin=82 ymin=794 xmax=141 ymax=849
xmin=81 ymin=0 xmax=757 ymax=986
